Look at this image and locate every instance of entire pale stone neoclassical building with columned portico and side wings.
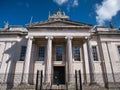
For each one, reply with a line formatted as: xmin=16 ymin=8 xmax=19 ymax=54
xmin=0 ymin=9 xmax=120 ymax=87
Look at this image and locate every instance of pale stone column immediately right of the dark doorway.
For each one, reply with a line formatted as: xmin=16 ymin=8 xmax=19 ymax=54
xmin=65 ymin=36 xmax=73 ymax=83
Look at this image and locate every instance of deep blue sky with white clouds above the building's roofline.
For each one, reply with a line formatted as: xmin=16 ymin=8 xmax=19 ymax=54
xmin=0 ymin=0 xmax=120 ymax=27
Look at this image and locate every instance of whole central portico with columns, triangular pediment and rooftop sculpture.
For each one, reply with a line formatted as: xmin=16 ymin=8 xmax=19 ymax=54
xmin=19 ymin=10 xmax=91 ymax=85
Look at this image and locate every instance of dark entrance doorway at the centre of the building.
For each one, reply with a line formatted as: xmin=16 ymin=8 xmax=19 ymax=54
xmin=53 ymin=66 xmax=65 ymax=85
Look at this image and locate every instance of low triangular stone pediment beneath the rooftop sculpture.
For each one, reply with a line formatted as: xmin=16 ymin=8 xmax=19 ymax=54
xmin=27 ymin=20 xmax=91 ymax=27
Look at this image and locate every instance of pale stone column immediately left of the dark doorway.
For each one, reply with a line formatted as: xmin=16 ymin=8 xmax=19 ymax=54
xmin=45 ymin=36 xmax=53 ymax=84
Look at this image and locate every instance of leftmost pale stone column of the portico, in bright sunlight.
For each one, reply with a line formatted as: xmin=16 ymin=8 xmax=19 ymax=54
xmin=22 ymin=37 xmax=33 ymax=84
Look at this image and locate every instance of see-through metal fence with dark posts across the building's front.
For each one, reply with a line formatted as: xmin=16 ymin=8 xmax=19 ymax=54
xmin=0 ymin=71 xmax=120 ymax=90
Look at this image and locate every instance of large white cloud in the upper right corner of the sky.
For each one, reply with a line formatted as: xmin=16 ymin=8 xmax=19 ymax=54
xmin=96 ymin=0 xmax=120 ymax=25
